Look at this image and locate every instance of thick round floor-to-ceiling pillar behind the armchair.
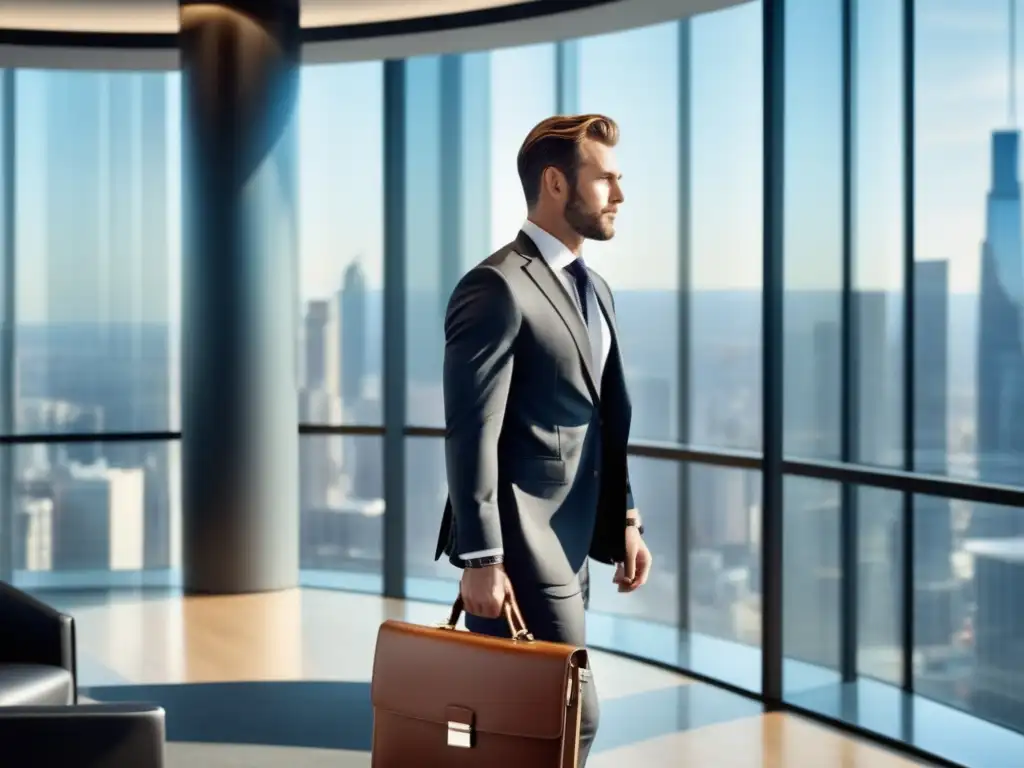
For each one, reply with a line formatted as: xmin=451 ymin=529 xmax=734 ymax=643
xmin=180 ymin=0 xmax=299 ymax=594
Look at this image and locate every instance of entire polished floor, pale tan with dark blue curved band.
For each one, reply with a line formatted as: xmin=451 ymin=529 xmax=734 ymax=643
xmin=46 ymin=590 xmax=937 ymax=768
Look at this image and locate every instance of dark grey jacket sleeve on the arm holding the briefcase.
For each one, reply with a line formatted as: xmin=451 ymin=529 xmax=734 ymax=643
xmin=443 ymin=266 xmax=522 ymax=560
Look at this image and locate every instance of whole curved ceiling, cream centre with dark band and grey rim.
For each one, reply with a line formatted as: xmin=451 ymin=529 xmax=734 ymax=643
xmin=0 ymin=0 xmax=751 ymax=71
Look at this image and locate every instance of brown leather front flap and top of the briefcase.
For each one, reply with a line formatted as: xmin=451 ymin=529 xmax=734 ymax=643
xmin=371 ymin=621 xmax=587 ymax=739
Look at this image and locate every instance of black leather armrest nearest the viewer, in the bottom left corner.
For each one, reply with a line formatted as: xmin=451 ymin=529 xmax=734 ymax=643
xmin=0 ymin=703 xmax=165 ymax=768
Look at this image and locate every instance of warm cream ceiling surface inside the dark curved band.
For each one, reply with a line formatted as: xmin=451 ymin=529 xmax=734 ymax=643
xmin=0 ymin=0 xmax=540 ymax=34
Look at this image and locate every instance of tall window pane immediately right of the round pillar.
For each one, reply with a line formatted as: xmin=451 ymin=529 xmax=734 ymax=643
xmin=296 ymin=61 xmax=384 ymax=592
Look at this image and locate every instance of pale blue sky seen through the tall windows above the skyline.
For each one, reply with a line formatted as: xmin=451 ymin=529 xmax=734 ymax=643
xmin=17 ymin=0 xmax=1024 ymax=317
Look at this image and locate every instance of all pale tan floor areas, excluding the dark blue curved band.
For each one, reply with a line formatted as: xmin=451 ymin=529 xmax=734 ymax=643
xmin=60 ymin=590 xmax=933 ymax=768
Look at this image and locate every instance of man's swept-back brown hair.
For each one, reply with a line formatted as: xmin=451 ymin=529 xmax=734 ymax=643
xmin=516 ymin=115 xmax=618 ymax=208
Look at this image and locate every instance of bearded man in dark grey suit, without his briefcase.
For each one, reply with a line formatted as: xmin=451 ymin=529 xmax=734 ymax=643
xmin=436 ymin=115 xmax=651 ymax=766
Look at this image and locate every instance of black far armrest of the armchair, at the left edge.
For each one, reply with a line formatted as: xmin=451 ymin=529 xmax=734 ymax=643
xmin=0 ymin=582 xmax=78 ymax=700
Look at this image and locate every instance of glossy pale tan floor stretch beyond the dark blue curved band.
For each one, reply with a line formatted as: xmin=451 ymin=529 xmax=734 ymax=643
xmin=74 ymin=590 xmax=689 ymax=696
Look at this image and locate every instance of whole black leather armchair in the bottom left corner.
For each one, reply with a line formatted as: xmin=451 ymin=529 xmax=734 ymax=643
xmin=0 ymin=582 xmax=165 ymax=768
